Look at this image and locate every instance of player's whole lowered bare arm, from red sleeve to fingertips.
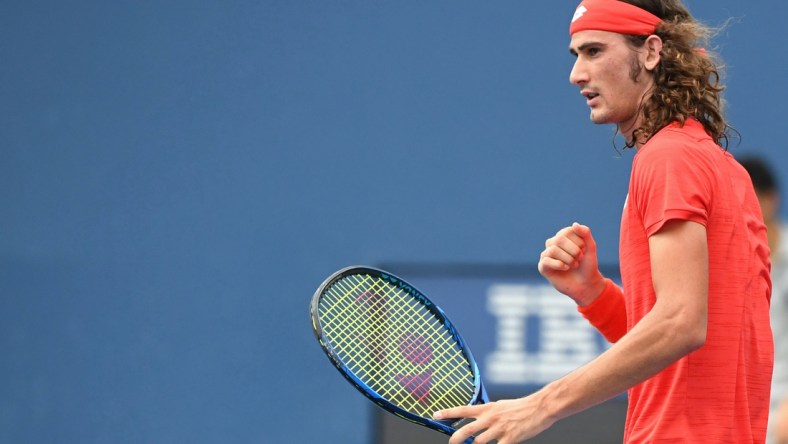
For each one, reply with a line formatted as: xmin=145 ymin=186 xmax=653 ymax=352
xmin=434 ymin=221 xmax=708 ymax=444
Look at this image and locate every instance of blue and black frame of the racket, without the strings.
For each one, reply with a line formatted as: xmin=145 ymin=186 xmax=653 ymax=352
xmin=309 ymin=266 xmax=490 ymax=443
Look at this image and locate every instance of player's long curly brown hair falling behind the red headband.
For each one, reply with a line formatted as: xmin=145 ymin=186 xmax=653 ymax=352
xmin=619 ymin=0 xmax=735 ymax=147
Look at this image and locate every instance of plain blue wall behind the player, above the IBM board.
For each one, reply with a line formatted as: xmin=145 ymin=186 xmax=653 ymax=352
xmin=0 ymin=0 xmax=788 ymax=444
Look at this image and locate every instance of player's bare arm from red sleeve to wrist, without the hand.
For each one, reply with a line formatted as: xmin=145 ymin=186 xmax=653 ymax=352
xmin=542 ymin=220 xmax=708 ymax=424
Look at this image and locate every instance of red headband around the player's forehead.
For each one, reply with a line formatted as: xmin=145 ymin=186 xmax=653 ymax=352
xmin=569 ymin=0 xmax=662 ymax=36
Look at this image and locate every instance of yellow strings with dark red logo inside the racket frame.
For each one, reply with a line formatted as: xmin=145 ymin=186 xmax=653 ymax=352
xmin=320 ymin=275 xmax=474 ymax=416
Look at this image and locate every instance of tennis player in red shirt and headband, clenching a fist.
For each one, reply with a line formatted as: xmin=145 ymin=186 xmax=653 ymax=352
xmin=437 ymin=0 xmax=773 ymax=444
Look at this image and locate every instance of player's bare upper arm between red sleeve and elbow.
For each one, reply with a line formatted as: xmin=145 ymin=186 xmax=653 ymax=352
xmin=649 ymin=220 xmax=709 ymax=345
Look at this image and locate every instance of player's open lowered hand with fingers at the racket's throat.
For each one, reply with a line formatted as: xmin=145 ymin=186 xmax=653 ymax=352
xmin=433 ymin=395 xmax=557 ymax=444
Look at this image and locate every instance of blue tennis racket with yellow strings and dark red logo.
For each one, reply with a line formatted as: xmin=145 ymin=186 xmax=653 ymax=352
xmin=310 ymin=267 xmax=489 ymax=442
